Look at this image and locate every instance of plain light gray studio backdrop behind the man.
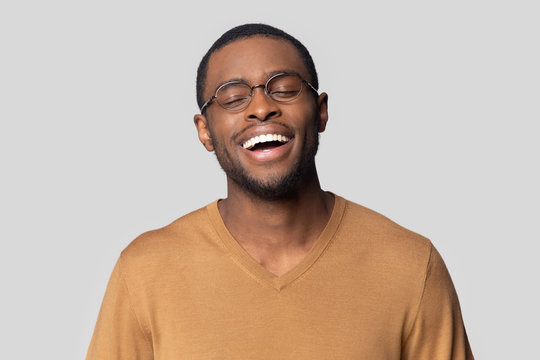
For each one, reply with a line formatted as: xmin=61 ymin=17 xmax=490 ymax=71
xmin=0 ymin=0 xmax=540 ymax=360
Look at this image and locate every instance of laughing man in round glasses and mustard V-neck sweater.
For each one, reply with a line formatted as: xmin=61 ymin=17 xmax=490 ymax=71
xmin=87 ymin=24 xmax=473 ymax=360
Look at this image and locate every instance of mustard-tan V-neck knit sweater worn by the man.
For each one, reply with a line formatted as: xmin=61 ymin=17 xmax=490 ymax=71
xmin=87 ymin=196 xmax=473 ymax=360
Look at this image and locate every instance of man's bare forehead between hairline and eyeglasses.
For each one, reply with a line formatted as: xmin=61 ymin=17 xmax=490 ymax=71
xmin=205 ymin=36 xmax=309 ymax=93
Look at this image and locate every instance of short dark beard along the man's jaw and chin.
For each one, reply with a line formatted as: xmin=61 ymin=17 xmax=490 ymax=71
xmin=208 ymin=121 xmax=319 ymax=200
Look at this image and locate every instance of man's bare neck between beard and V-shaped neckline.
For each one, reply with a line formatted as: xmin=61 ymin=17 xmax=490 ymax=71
xmin=219 ymin=169 xmax=334 ymax=255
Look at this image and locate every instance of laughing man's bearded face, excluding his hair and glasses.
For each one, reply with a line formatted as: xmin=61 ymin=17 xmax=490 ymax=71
xmin=195 ymin=36 xmax=328 ymax=199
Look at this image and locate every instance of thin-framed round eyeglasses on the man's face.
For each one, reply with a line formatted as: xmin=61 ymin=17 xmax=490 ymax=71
xmin=201 ymin=73 xmax=318 ymax=114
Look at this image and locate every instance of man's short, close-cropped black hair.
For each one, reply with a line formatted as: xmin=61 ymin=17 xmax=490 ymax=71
xmin=197 ymin=24 xmax=319 ymax=109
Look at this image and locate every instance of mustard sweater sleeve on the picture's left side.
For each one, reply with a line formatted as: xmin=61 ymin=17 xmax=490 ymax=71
xmin=86 ymin=257 xmax=154 ymax=360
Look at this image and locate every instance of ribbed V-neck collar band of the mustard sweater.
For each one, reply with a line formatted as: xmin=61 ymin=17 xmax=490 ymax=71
xmin=206 ymin=195 xmax=346 ymax=291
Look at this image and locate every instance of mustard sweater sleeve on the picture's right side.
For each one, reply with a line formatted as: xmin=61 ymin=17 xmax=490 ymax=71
xmin=402 ymin=246 xmax=474 ymax=360
